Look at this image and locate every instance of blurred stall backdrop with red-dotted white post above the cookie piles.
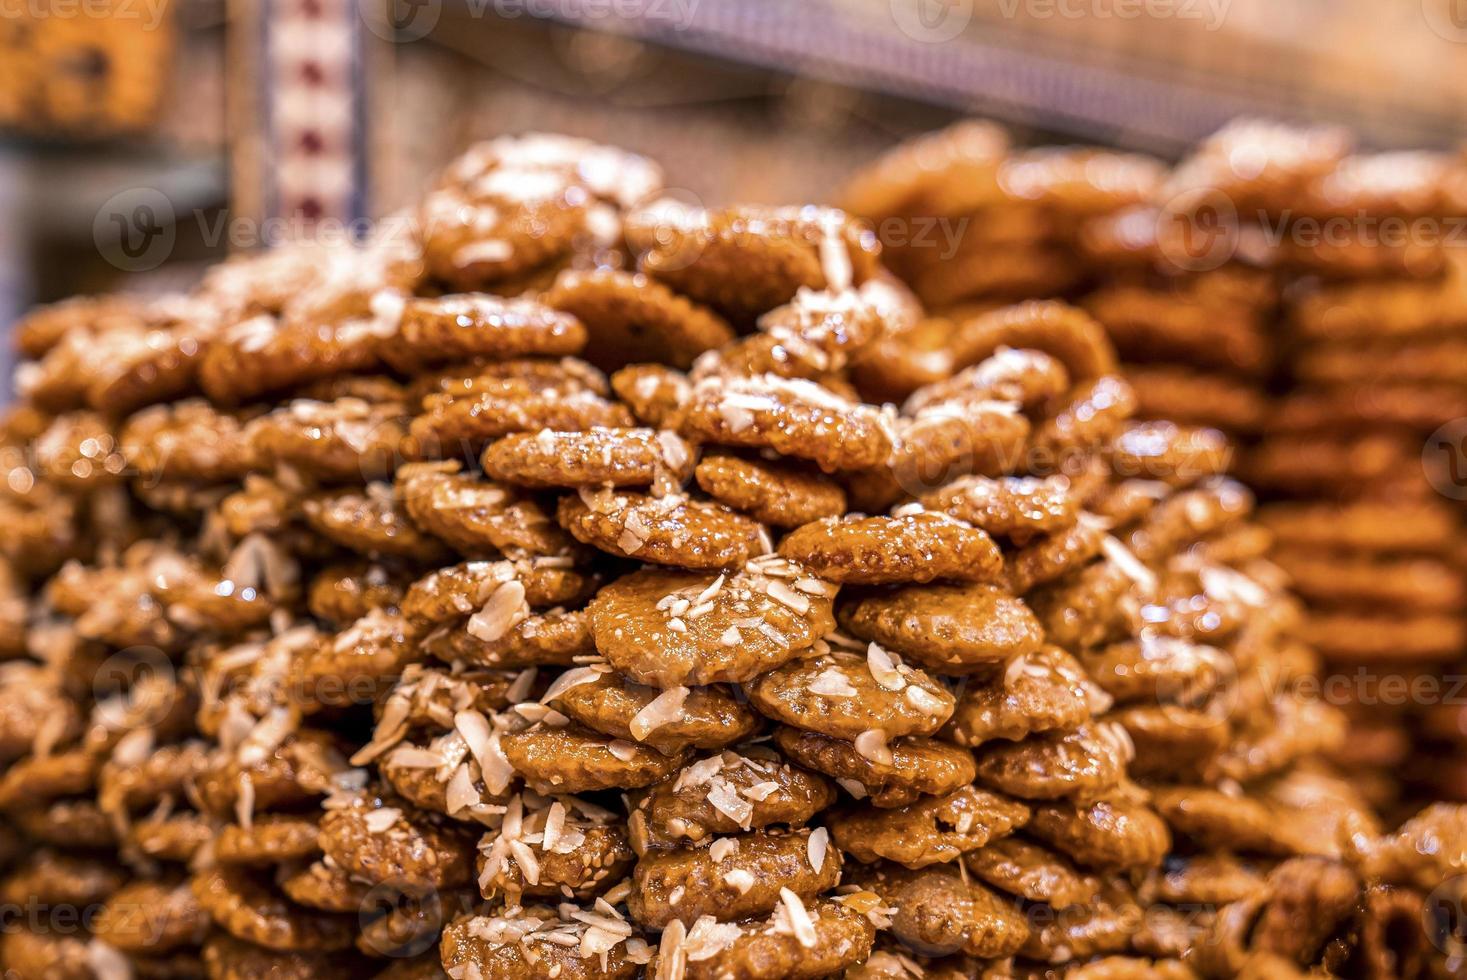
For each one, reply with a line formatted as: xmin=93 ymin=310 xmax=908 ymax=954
xmin=0 ymin=0 xmax=1467 ymax=352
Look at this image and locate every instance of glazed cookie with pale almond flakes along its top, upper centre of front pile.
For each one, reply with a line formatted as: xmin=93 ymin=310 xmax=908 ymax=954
xmin=681 ymin=374 xmax=892 ymax=472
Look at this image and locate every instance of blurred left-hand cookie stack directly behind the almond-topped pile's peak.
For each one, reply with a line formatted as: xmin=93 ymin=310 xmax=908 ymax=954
xmin=842 ymin=122 xmax=1278 ymax=442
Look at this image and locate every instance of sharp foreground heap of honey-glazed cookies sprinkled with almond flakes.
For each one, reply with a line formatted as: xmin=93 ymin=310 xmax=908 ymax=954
xmin=0 ymin=136 xmax=1467 ymax=980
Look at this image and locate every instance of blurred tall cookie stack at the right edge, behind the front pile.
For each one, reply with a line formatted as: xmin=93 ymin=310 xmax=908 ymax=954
xmin=1243 ymin=144 xmax=1467 ymax=804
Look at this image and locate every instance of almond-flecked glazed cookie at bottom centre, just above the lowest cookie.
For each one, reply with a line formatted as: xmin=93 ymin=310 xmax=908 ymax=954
xmin=626 ymin=827 xmax=842 ymax=929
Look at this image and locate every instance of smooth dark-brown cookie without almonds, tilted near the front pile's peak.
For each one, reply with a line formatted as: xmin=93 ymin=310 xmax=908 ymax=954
xmin=544 ymin=268 xmax=734 ymax=371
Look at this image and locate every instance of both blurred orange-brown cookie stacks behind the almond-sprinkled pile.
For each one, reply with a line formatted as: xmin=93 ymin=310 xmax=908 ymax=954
xmin=844 ymin=120 xmax=1467 ymax=805
